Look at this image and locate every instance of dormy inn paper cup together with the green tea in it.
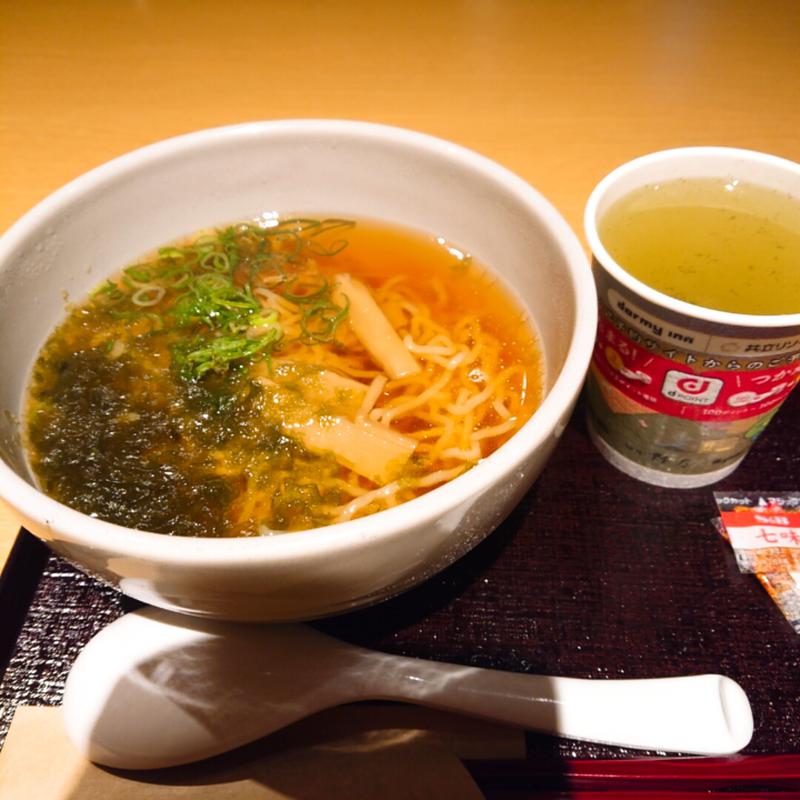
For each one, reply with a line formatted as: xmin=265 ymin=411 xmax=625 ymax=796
xmin=586 ymin=147 xmax=800 ymax=487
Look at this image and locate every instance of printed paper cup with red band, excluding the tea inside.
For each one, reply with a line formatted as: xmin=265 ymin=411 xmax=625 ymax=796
xmin=585 ymin=147 xmax=800 ymax=488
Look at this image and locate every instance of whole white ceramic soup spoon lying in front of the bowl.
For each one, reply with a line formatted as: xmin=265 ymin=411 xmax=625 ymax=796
xmin=64 ymin=608 xmax=753 ymax=769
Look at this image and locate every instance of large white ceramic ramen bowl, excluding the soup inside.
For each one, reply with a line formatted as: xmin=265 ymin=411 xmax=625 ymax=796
xmin=0 ymin=120 xmax=596 ymax=620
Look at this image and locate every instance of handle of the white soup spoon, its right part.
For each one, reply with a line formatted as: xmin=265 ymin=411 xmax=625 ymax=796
xmin=356 ymin=654 xmax=753 ymax=755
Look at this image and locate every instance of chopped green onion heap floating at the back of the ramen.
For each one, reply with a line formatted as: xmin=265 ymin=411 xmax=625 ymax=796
xmin=96 ymin=217 xmax=354 ymax=380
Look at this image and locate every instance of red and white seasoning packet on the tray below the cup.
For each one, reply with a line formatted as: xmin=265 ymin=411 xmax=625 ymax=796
xmin=714 ymin=492 xmax=800 ymax=633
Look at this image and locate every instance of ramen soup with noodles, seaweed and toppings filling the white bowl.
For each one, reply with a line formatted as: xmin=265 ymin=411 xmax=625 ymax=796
xmin=26 ymin=216 xmax=542 ymax=536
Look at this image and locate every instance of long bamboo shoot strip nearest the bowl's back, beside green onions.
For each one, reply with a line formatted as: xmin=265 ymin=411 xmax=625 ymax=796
xmin=335 ymin=275 xmax=420 ymax=379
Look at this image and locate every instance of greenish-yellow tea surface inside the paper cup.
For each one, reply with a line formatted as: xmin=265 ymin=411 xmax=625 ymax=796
xmin=598 ymin=178 xmax=800 ymax=314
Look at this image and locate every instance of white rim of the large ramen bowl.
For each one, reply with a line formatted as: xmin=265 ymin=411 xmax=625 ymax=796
xmin=0 ymin=119 xmax=597 ymax=569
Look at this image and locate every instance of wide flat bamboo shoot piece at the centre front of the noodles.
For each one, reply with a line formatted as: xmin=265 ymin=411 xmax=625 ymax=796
xmin=294 ymin=417 xmax=417 ymax=486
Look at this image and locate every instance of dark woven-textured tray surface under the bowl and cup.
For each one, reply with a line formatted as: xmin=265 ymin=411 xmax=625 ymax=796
xmin=0 ymin=392 xmax=800 ymax=758
